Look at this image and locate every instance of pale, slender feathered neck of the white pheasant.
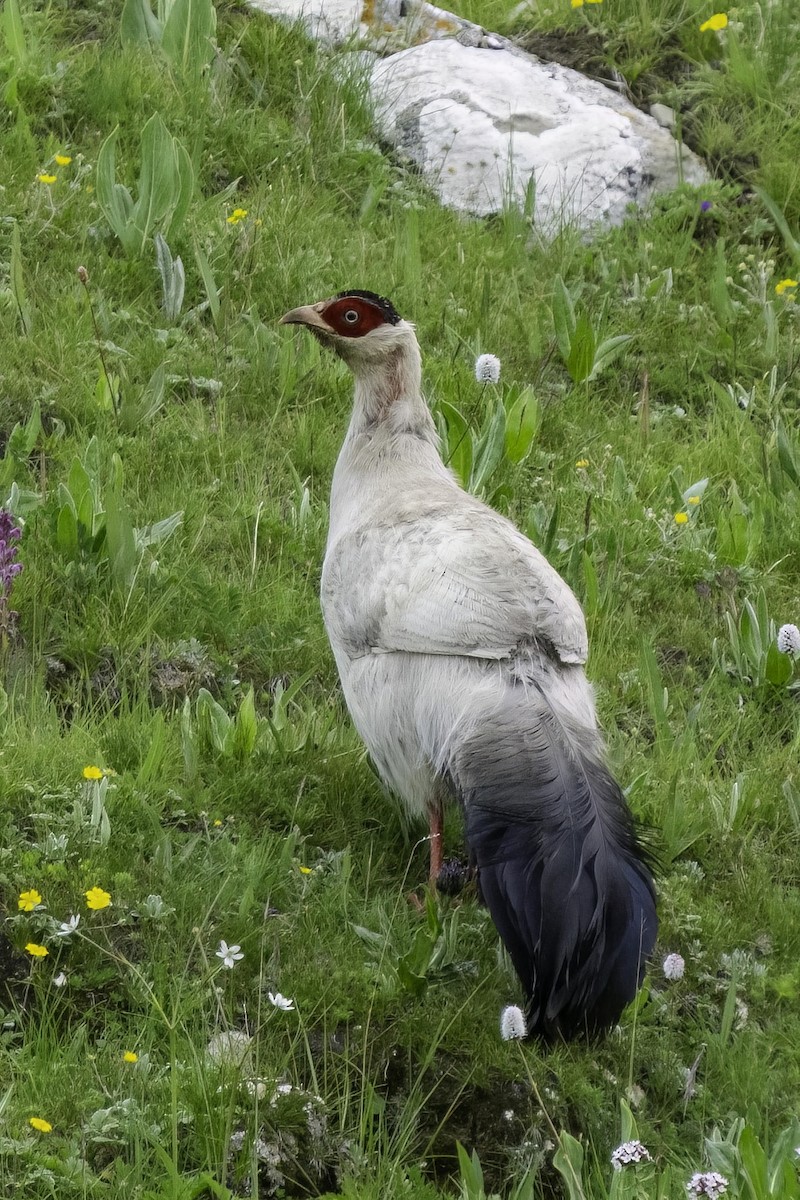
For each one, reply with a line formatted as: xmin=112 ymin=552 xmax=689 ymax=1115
xmin=348 ymin=336 xmax=437 ymax=445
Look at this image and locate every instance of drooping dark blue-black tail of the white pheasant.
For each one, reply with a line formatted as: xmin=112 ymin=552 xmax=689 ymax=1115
xmin=451 ymin=685 xmax=657 ymax=1038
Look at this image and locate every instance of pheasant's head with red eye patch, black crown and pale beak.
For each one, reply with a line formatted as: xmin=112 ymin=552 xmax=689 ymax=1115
xmin=281 ymin=290 xmax=416 ymax=374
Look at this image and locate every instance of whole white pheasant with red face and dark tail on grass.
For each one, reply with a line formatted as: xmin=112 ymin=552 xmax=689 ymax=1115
xmin=282 ymin=290 xmax=657 ymax=1038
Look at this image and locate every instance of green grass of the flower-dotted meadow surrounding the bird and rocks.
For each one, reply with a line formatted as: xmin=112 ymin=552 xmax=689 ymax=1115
xmin=0 ymin=0 xmax=800 ymax=1200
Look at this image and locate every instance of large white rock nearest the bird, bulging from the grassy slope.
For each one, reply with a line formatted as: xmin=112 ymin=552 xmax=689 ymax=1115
xmin=372 ymin=40 xmax=706 ymax=233
